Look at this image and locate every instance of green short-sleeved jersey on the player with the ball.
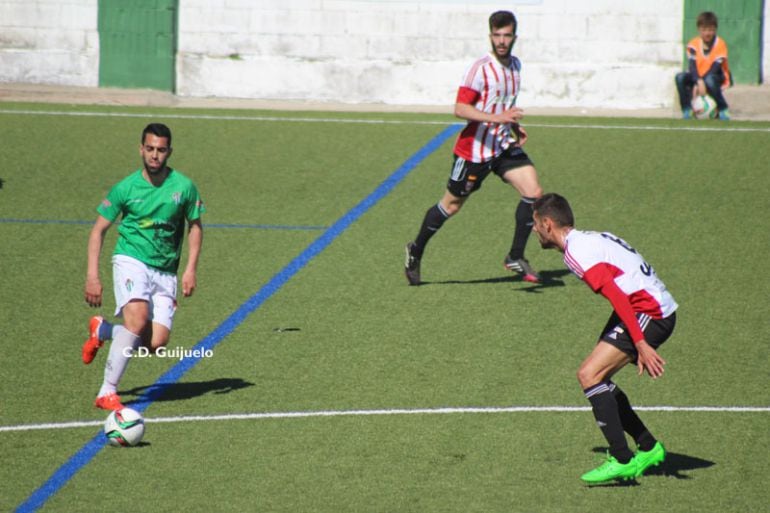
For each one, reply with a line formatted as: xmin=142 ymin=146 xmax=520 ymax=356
xmin=96 ymin=169 xmax=206 ymax=274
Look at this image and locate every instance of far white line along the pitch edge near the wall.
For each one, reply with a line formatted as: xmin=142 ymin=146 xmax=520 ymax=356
xmin=0 ymin=109 xmax=770 ymax=133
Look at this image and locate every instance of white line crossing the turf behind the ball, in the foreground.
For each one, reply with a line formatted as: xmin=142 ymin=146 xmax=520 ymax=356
xmin=0 ymin=406 xmax=770 ymax=433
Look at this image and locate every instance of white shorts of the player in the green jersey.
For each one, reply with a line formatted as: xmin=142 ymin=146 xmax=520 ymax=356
xmin=112 ymin=255 xmax=176 ymax=330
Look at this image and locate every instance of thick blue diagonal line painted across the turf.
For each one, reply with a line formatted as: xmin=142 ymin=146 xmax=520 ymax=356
xmin=16 ymin=125 xmax=461 ymax=512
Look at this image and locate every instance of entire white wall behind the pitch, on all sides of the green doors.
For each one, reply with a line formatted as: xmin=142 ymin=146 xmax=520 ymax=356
xmin=0 ymin=0 xmax=770 ymax=108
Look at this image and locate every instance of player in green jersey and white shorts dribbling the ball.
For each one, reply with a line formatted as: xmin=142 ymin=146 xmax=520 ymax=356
xmin=83 ymin=123 xmax=205 ymax=410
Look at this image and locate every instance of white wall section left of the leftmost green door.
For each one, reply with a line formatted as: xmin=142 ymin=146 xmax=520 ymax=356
xmin=0 ymin=0 xmax=99 ymax=86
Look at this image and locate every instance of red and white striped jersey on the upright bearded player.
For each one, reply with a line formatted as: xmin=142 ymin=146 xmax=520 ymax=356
xmin=454 ymin=53 xmax=521 ymax=162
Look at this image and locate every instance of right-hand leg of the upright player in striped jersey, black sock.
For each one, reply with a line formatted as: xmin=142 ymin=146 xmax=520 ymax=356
xmin=501 ymin=160 xmax=543 ymax=283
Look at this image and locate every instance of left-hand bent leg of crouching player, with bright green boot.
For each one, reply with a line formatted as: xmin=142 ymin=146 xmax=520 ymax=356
xmin=577 ymin=341 xmax=638 ymax=484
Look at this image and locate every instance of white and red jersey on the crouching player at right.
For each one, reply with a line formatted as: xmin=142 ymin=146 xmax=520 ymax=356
xmin=564 ymin=229 xmax=678 ymax=319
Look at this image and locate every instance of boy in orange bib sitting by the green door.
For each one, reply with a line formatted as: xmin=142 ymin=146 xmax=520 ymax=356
xmin=676 ymin=11 xmax=733 ymax=121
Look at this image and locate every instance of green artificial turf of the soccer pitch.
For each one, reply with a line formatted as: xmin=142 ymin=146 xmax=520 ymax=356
xmin=0 ymin=104 xmax=770 ymax=512
